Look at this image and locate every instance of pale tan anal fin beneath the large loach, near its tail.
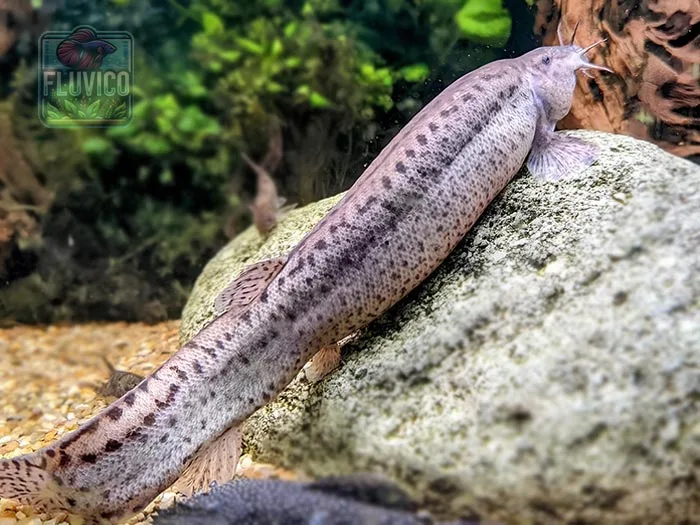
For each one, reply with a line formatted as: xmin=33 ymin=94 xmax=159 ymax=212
xmin=172 ymin=425 xmax=243 ymax=496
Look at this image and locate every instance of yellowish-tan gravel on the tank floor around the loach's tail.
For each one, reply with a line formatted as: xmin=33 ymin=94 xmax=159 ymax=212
xmin=0 ymin=321 xmax=295 ymax=525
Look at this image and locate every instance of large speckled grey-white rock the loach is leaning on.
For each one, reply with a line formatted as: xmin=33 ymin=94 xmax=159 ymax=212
xmin=182 ymin=132 xmax=700 ymax=524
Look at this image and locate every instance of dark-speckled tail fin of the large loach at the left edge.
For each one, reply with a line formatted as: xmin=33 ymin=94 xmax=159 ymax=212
xmin=0 ymin=451 xmax=69 ymax=512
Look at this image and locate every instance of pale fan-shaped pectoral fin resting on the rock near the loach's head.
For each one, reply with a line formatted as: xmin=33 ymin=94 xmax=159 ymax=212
xmin=527 ymin=131 xmax=598 ymax=180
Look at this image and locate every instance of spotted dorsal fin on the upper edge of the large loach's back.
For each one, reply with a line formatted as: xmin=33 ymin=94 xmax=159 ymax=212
xmin=214 ymin=257 xmax=287 ymax=317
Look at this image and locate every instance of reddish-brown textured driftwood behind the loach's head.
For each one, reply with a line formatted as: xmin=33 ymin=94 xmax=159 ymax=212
xmin=535 ymin=0 xmax=700 ymax=158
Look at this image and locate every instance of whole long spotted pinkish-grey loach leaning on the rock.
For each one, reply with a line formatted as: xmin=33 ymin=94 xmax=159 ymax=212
xmin=0 ymin=32 xmax=605 ymax=523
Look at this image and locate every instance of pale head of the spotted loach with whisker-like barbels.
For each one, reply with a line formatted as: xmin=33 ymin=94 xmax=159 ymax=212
xmin=519 ymin=24 xmax=613 ymax=122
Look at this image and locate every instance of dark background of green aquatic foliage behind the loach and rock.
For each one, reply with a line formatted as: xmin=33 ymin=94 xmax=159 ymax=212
xmin=0 ymin=0 xmax=532 ymax=322
